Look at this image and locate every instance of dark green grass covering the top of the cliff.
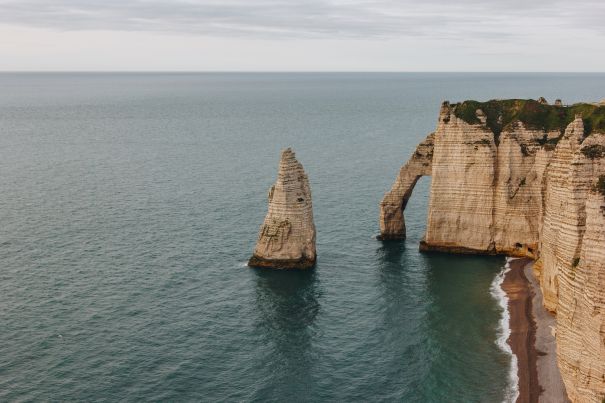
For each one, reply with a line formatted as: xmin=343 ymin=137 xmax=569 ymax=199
xmin=453 ymin=99 xmax=605 ymax=139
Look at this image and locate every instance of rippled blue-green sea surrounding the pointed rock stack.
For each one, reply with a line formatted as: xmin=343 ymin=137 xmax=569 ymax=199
xmin=0 ymin=74 xmax=605 ymax=402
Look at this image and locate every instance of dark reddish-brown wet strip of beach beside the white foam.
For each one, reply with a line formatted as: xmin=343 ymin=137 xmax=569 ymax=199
xmin=501 ymin=258 xmax=542 ymax=403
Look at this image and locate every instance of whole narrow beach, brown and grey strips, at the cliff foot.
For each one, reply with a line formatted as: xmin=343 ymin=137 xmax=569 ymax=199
xmin=502 ymin=258 xmax=569 ymax=403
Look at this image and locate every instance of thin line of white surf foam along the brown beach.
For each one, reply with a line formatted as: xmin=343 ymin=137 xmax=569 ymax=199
xmin=490 ymin=257 xmax=519 ymax=402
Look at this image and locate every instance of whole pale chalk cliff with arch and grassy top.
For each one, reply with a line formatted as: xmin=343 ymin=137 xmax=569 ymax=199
xmin=380 ymin=100 xmax=605 ymax=402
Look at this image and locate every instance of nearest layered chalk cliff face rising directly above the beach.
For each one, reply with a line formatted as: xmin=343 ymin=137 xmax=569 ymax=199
xmin=540 ymin=133 xmax=605 ymax=402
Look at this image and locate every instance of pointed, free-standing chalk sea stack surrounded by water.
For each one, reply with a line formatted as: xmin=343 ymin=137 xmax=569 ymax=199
xmin=248 ymin=148 xmax=316 ymax=269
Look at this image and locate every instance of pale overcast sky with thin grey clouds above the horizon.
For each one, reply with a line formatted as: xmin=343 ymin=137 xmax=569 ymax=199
xmin=0 ymin=0 xmax=605 ymax=72
